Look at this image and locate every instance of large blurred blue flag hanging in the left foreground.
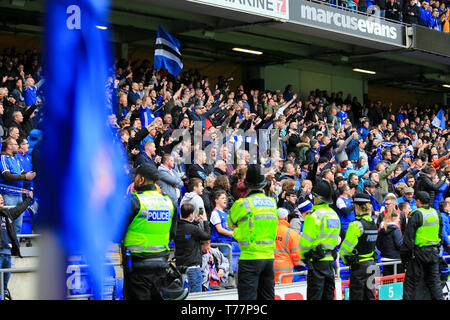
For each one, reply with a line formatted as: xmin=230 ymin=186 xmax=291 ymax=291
xmin=36 ymin=0 xmax=129 ymax=299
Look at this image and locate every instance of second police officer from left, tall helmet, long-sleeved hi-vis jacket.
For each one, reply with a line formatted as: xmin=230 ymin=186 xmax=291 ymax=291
xmin=228 ymin=164 xmax=278 ymax=300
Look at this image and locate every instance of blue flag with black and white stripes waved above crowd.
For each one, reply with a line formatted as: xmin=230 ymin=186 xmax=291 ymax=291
xmin=154 ymin=26 xmax=183 ymax=77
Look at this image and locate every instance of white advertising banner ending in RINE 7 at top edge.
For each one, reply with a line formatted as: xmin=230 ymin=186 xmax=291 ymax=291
xmin=189 ymin=0 xmax=289 ymax=19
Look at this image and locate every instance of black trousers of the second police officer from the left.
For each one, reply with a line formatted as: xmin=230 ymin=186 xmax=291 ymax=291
xmin=237 ymin=259 xmax=275 ymax=300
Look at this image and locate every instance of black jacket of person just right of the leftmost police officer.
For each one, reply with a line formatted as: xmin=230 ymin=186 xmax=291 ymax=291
xmin=175 ymin=220 xmax=211 ymax=267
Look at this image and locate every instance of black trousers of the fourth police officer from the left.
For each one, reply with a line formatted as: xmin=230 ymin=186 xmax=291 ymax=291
xmin=349 ymin=261 xmax=376 ymax=300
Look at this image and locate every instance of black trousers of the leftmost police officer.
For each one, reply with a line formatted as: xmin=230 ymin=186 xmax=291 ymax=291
xmin=123 ymin=259 xmax=167 ymax=300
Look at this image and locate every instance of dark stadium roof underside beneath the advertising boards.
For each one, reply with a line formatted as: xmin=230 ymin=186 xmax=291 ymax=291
xmin=0 ymin=0 xmax=450 ymax=92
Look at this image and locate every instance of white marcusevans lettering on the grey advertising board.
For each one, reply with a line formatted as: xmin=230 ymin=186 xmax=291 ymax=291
xmin=300 ymin=4 xmax=398 ymax=40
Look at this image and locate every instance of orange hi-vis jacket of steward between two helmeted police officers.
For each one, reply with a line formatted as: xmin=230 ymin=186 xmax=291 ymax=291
xmin=273 ymin=220 xmax=301 ymax=283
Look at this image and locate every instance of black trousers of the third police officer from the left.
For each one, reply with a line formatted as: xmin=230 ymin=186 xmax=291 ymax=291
xmin=306 ymin=261 xmax=335 ymax=300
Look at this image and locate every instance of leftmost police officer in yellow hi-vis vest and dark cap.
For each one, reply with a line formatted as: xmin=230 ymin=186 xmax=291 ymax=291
xmin=122 ymin=164 xmax=177 ymax=300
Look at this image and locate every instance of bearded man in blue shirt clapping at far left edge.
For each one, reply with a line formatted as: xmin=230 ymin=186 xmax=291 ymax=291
xmin=0 ymin=138 xmax=36 ymax=234
